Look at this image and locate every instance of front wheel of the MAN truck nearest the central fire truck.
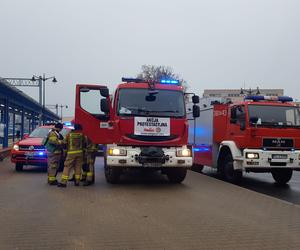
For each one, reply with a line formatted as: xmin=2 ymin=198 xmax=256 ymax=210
xmin=221 ymin=155 xmax=243 ymax=183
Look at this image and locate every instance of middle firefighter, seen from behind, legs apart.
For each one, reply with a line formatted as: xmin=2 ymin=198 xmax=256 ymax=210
xmin=57 ymin=124 xmax=86 ymax=187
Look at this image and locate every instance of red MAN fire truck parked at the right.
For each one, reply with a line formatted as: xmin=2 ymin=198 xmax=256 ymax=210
xmin=189 ymin=96 xmax=300 ymax=184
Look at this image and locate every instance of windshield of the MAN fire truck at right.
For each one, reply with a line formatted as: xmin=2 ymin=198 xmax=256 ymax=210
xmin=248 ymin=104 xmax=300 ymax=127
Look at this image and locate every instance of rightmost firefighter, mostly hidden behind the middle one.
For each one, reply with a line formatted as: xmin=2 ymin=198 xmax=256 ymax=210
xmin=83 ymin=137 xmax=98 ymax=186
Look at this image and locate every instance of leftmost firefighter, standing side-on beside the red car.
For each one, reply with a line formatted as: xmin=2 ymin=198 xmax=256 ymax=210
xmin=44 ymin=123 xmax=64 ymax=185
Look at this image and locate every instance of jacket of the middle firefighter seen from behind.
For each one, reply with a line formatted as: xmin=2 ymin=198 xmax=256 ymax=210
xmin=65 ymin=130 xmax=86 ymax=154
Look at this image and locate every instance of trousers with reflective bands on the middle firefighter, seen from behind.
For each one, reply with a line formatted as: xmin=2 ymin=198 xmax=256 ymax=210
xmin=61 ymin=153 xmax=83 ymax=184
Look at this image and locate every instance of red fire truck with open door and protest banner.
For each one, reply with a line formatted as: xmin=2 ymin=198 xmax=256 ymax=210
xmin=75 ymin=78 xmax=199 ymax=183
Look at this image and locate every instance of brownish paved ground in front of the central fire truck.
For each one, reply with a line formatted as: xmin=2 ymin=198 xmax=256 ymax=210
xmin=0 ymin=158 xmax=300 ymax=250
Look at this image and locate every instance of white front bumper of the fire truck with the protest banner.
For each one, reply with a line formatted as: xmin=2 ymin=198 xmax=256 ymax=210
xmin=106 ymin=145 xmax=193 ymax=168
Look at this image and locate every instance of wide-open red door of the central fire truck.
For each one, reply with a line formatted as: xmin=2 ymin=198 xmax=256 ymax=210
xmin=75 ymin=84 xmax=114 ymax=144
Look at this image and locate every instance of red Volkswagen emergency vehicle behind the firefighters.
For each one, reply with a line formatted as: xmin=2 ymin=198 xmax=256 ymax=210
xmin=11 ymin=125 xmax=71 ymax=171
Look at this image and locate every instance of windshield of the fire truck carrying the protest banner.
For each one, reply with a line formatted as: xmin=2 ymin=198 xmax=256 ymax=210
xmin=117 ymin=89 xmax=185 ymax=117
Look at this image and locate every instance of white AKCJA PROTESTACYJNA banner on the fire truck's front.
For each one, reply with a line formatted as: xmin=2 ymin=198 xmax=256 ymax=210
xmin=134 ymin=117 xmax=170 ymax=136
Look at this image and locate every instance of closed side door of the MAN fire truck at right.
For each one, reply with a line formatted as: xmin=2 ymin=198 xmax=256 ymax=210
xmin=229 ymin=105 xmax=246 ymax=145
